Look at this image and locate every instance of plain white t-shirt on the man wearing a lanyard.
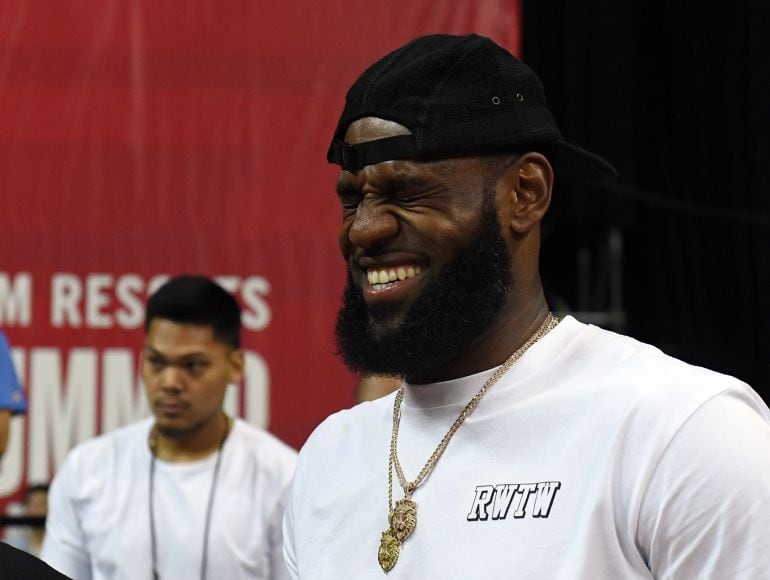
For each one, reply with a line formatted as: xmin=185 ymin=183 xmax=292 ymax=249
xmin=42 ymin=418 xmax=296 ymax=580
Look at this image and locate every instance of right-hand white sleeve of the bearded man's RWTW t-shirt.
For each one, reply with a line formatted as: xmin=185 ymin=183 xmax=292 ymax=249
xmin=637 ymin=389 xmax=770 ymax=580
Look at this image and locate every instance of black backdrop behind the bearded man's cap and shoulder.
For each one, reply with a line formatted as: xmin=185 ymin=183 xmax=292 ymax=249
xmin=522 ymin=0 xmax=770 ymax=401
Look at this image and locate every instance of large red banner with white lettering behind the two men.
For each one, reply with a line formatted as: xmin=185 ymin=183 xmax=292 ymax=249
xmin=0 ymin=0 xmax=519 ymax=508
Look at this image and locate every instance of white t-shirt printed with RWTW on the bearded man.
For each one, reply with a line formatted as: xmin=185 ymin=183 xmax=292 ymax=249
xmin=284 ymin=317 xmax=770 ymax=580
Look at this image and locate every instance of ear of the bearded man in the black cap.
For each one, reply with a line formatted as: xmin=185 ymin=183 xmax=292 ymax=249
xmin=497 ymin=151 xmax=553 ymax=235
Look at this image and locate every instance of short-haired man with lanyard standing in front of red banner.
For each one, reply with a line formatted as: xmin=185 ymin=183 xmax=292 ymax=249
xmin=42 ymin=276 xmax=296 ymax=580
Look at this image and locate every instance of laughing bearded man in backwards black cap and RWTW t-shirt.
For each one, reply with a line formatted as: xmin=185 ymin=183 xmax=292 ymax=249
xmin=284 ymin=35 xmax=770 ymax=580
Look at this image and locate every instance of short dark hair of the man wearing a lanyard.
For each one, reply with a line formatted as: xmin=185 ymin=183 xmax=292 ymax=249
xmin=144 ymin=275 xmax=241 ymax=349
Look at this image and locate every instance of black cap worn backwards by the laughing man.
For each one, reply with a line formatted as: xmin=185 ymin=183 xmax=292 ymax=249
xmin=327 ymin=34 xmax=616 ymax=179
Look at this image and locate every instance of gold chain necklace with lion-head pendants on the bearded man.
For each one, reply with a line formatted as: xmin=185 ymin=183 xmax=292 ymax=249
xmin=377 ymin=312 xmax=559 ymax=573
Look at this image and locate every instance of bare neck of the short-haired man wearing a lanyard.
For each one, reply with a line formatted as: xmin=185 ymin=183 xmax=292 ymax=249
xmin=150 ymin=413 xmax=231 ymax=463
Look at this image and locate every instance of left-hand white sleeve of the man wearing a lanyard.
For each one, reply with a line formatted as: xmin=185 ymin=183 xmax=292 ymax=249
xmin=40 ymin=457 xmax=91 ymax=580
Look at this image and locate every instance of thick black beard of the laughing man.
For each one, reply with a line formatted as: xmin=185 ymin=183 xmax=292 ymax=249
xmin=336 ymin=202 xmax=513 ymax=380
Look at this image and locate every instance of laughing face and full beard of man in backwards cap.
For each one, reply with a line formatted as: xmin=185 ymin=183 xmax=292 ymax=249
xmin=337 ymin=147 xmax=511 ymax=379
